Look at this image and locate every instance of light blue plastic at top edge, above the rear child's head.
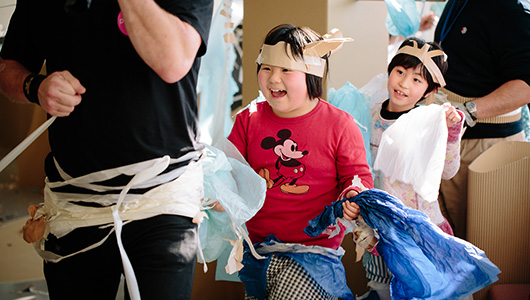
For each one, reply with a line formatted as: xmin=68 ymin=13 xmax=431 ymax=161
xmin=385 ymin=0 xmax=420 ymax=37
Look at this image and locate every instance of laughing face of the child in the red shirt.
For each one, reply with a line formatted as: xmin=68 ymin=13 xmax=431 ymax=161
xmin=258 ymin=64 xmax=318 ymax=118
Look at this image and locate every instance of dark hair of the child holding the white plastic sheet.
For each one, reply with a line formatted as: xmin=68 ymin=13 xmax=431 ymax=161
xmin=388 ymin=37 xmax=447 ymax=95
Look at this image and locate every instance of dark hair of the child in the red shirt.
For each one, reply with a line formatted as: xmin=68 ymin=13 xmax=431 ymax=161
xmin=258 ymin=24 xmax=328 ymax=99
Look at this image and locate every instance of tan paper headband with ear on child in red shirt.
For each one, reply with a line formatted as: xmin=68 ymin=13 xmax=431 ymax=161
xmin=256 ymin=28 xmax=353 ymax=77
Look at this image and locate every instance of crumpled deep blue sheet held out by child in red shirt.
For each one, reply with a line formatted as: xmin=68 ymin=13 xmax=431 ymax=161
xmin=304 ymin=189 xmax=500 ymax=299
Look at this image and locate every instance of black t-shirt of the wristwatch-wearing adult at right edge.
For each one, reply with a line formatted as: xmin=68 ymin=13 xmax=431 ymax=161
xmin=434 ymin=0 xmax=530 ymax=139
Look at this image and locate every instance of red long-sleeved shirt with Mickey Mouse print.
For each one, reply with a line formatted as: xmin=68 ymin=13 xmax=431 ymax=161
xmin=228 ymin=100 xmax=373 ymax=249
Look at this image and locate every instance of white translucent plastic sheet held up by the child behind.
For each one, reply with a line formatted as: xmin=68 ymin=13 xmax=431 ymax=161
xmin=374 ymin=104 xmax=448 ymax=203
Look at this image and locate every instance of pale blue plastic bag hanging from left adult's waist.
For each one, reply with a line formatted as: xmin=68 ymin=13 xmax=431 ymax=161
xmin=199 ymin=139 xmax=267 ymax=267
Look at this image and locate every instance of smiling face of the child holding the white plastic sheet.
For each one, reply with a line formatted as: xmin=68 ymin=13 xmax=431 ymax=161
xmin=388 ymin=65 xmax=430 ymax=112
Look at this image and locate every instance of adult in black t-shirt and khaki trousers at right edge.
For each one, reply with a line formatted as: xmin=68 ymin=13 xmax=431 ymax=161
xmin=435 ymin=0 xmax=530 ymax=238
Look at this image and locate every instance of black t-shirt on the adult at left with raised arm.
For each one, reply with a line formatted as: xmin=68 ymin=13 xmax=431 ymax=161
xmin=1 ymin=0 xmax=213 ymax=181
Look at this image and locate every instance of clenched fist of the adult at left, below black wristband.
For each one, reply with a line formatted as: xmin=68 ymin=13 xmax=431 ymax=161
xmin=38 ymin=71 xmax=86 ymax=117
